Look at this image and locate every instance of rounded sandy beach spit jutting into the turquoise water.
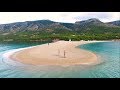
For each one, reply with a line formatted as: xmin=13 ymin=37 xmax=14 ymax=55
xmin=5 ymin=41 xmax=109 ymax=66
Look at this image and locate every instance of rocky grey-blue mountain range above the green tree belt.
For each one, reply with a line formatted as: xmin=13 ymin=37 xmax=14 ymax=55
xmin=0 ymin=18 xmax=120 ymax=34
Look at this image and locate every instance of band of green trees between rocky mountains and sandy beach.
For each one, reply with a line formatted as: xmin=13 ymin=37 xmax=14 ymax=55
xmin=0 ymin=31 xmax=120 ymax=41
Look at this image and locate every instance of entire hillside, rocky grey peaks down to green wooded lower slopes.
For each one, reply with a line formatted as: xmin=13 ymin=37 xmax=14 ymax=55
xmin=0 ymin=18 xmax=120 ymax=41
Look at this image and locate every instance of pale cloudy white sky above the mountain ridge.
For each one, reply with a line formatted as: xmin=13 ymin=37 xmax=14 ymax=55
xmin=0 ymin=12 xmax=120 ymax=24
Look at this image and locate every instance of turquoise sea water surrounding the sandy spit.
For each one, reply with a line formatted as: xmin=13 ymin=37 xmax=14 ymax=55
xmin=0 ymin=42 xmax=120 ymax=78
